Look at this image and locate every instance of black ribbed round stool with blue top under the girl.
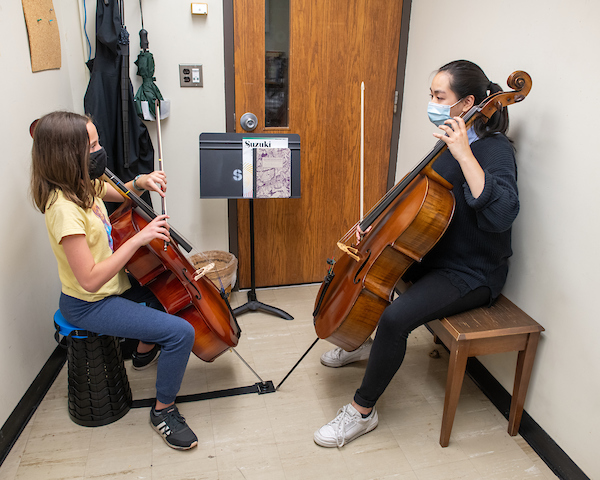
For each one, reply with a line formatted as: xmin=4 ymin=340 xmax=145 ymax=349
xmin=54 ymin=310 xmax=132 ymax=427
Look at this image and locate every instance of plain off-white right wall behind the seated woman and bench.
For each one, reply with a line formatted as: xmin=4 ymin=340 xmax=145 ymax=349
xmin=398 ymin=0 xmax=600 ymax=478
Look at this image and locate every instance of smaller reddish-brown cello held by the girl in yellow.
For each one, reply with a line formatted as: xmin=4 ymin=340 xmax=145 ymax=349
xmin=105 ymin=169 xmax=241 ymax=362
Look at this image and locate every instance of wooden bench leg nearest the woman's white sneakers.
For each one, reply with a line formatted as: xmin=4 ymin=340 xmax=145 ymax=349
xmin=440 ymin=342 xmax=469 ymax=447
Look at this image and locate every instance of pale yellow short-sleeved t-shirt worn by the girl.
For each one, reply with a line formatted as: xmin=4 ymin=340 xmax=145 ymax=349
xmin=45 ymin=185 xmax=131 ymax=302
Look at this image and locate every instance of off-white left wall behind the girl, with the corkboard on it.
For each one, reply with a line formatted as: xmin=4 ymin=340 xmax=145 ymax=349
xmin=0 ymin=0 xmax=90 ymax=432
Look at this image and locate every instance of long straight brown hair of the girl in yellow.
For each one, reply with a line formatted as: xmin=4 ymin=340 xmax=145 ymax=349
xmin=31 ymin=112 xmax=97 ymax=213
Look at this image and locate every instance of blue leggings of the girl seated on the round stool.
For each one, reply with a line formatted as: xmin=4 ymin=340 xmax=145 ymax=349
xmin=59 ymin=286 xmax=195 ymax=404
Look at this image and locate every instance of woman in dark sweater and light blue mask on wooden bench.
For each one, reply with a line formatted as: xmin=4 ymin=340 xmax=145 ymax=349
xmin=314 ymin=60 xmax=519 ymax=447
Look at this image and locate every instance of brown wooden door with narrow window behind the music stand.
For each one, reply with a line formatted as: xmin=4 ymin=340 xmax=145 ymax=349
xmin=233 ymin=0 xmax=402 ymax=288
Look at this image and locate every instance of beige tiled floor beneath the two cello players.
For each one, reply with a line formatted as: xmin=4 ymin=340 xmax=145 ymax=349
xmin=0 ymin=285 xmax=556 ymax=480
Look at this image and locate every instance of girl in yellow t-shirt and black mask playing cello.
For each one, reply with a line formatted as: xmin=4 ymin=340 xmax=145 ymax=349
xmin=31 ymin=112 xmax=198 ymax=450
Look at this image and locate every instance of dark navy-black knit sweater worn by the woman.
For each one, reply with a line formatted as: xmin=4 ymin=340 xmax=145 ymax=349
xmin=416 ymin=134 xmax=519 ymax=298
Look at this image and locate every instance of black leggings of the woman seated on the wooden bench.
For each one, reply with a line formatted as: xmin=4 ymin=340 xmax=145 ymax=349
xmin=354 ymin=271 xmax=491 ymax=408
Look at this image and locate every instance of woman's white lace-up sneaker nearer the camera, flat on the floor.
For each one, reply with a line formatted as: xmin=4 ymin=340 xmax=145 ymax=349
xmin=315 ymin=403 xmax=379 ymax=447
